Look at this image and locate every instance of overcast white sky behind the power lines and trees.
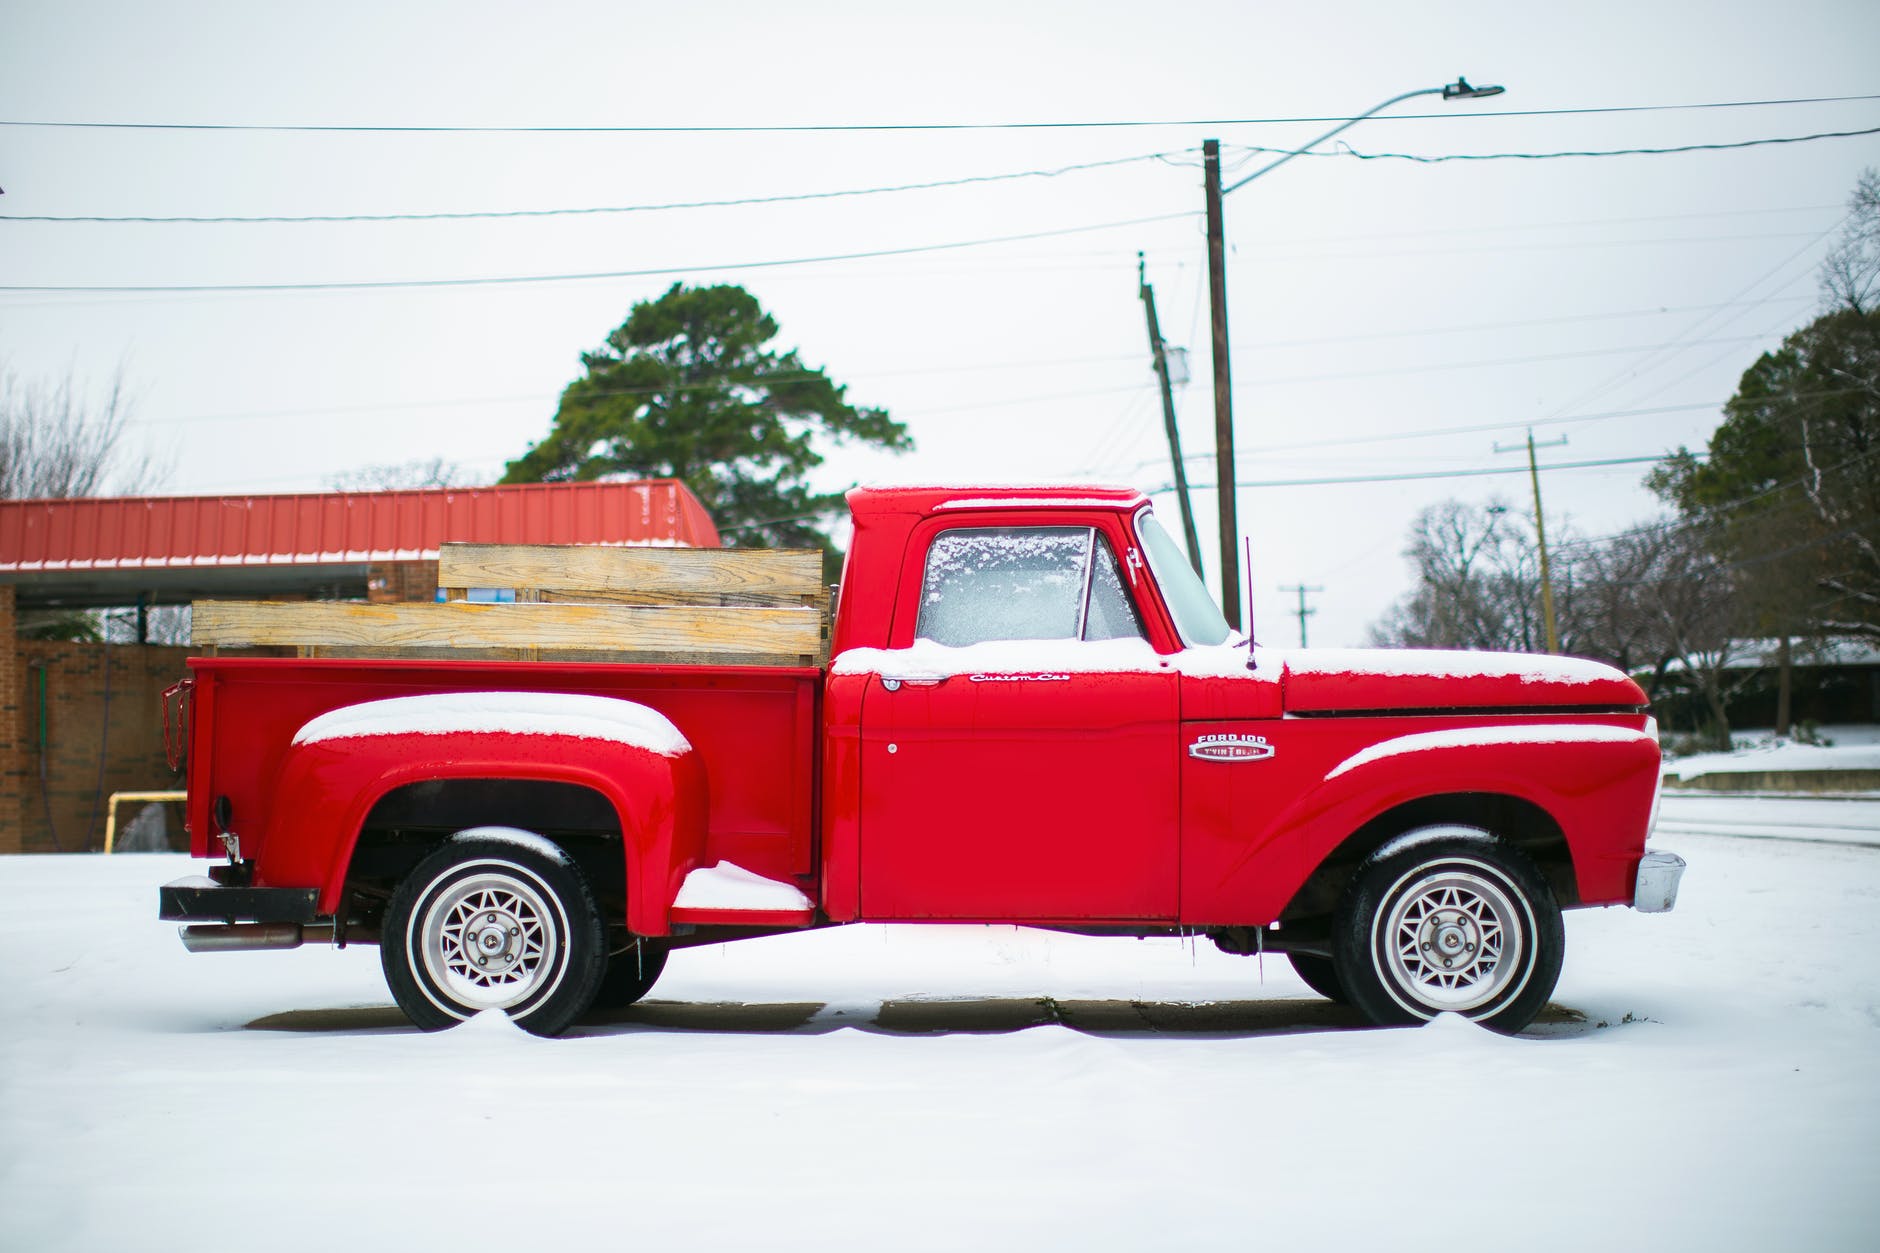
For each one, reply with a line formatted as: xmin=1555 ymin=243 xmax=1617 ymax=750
xmin=0 ymin=0 xmax=1880 ymax=643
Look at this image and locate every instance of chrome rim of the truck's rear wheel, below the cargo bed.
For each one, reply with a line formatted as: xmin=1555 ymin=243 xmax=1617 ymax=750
xmin=419 ymin=869 xmax=566 ymax=1014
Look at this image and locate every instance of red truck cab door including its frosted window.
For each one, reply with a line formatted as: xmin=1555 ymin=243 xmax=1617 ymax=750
xmin=861 ymin=525 xmax=1179 ymax=920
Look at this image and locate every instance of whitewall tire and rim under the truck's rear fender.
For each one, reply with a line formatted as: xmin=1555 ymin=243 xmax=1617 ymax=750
xmin=380 ymin=828 xmax=607 ymax=1035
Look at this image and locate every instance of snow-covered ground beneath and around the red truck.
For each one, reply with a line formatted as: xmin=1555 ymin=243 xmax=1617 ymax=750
xmin=0 ymin=798 xmax=1880 ymax=1253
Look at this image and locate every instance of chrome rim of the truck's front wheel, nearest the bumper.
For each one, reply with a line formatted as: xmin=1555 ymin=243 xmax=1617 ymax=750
xmin=1372 ymin=864 xmax=1530 ymax=1018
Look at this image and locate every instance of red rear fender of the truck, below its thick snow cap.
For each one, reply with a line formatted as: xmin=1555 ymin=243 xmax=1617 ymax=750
xmin=256 ymin=694 xmax=707 ymax=935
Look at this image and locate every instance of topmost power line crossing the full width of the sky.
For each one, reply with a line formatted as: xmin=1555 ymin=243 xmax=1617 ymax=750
xmin=0 ymin=94 xmax=1880 ymax=135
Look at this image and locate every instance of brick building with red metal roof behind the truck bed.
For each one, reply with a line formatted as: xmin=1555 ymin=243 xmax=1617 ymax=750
xmin=0 ymin=480 xmax=718 ymax=852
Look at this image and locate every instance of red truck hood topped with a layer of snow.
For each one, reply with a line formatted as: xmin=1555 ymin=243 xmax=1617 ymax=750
xmin=1260 ymin=649 xmax=1647 ymax=713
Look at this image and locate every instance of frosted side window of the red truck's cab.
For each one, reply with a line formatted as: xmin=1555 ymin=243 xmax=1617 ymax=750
xmin=914 ymin=527 xmax=1143 ymax=647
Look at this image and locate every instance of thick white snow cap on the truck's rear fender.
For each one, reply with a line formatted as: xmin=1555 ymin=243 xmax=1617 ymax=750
xmin=293 ymin=692 xmax=692 ymax=756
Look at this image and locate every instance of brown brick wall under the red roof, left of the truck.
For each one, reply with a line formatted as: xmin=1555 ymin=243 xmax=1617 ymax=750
xmin=0 ymin=613 xmax=190 ymax=852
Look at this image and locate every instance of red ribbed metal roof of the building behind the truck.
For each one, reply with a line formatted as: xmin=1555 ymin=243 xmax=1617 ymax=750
xmin=0 ymin=478 xmax=720 ymax=574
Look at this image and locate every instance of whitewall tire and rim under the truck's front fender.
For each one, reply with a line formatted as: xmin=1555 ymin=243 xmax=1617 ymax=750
xmin=1333 ymin=826 xmax=1566 ymax=1033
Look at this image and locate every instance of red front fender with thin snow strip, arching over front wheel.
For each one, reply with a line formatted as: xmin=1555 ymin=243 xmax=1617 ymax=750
xmin=1209 ymin=724 xmax=1658 ymax=922
